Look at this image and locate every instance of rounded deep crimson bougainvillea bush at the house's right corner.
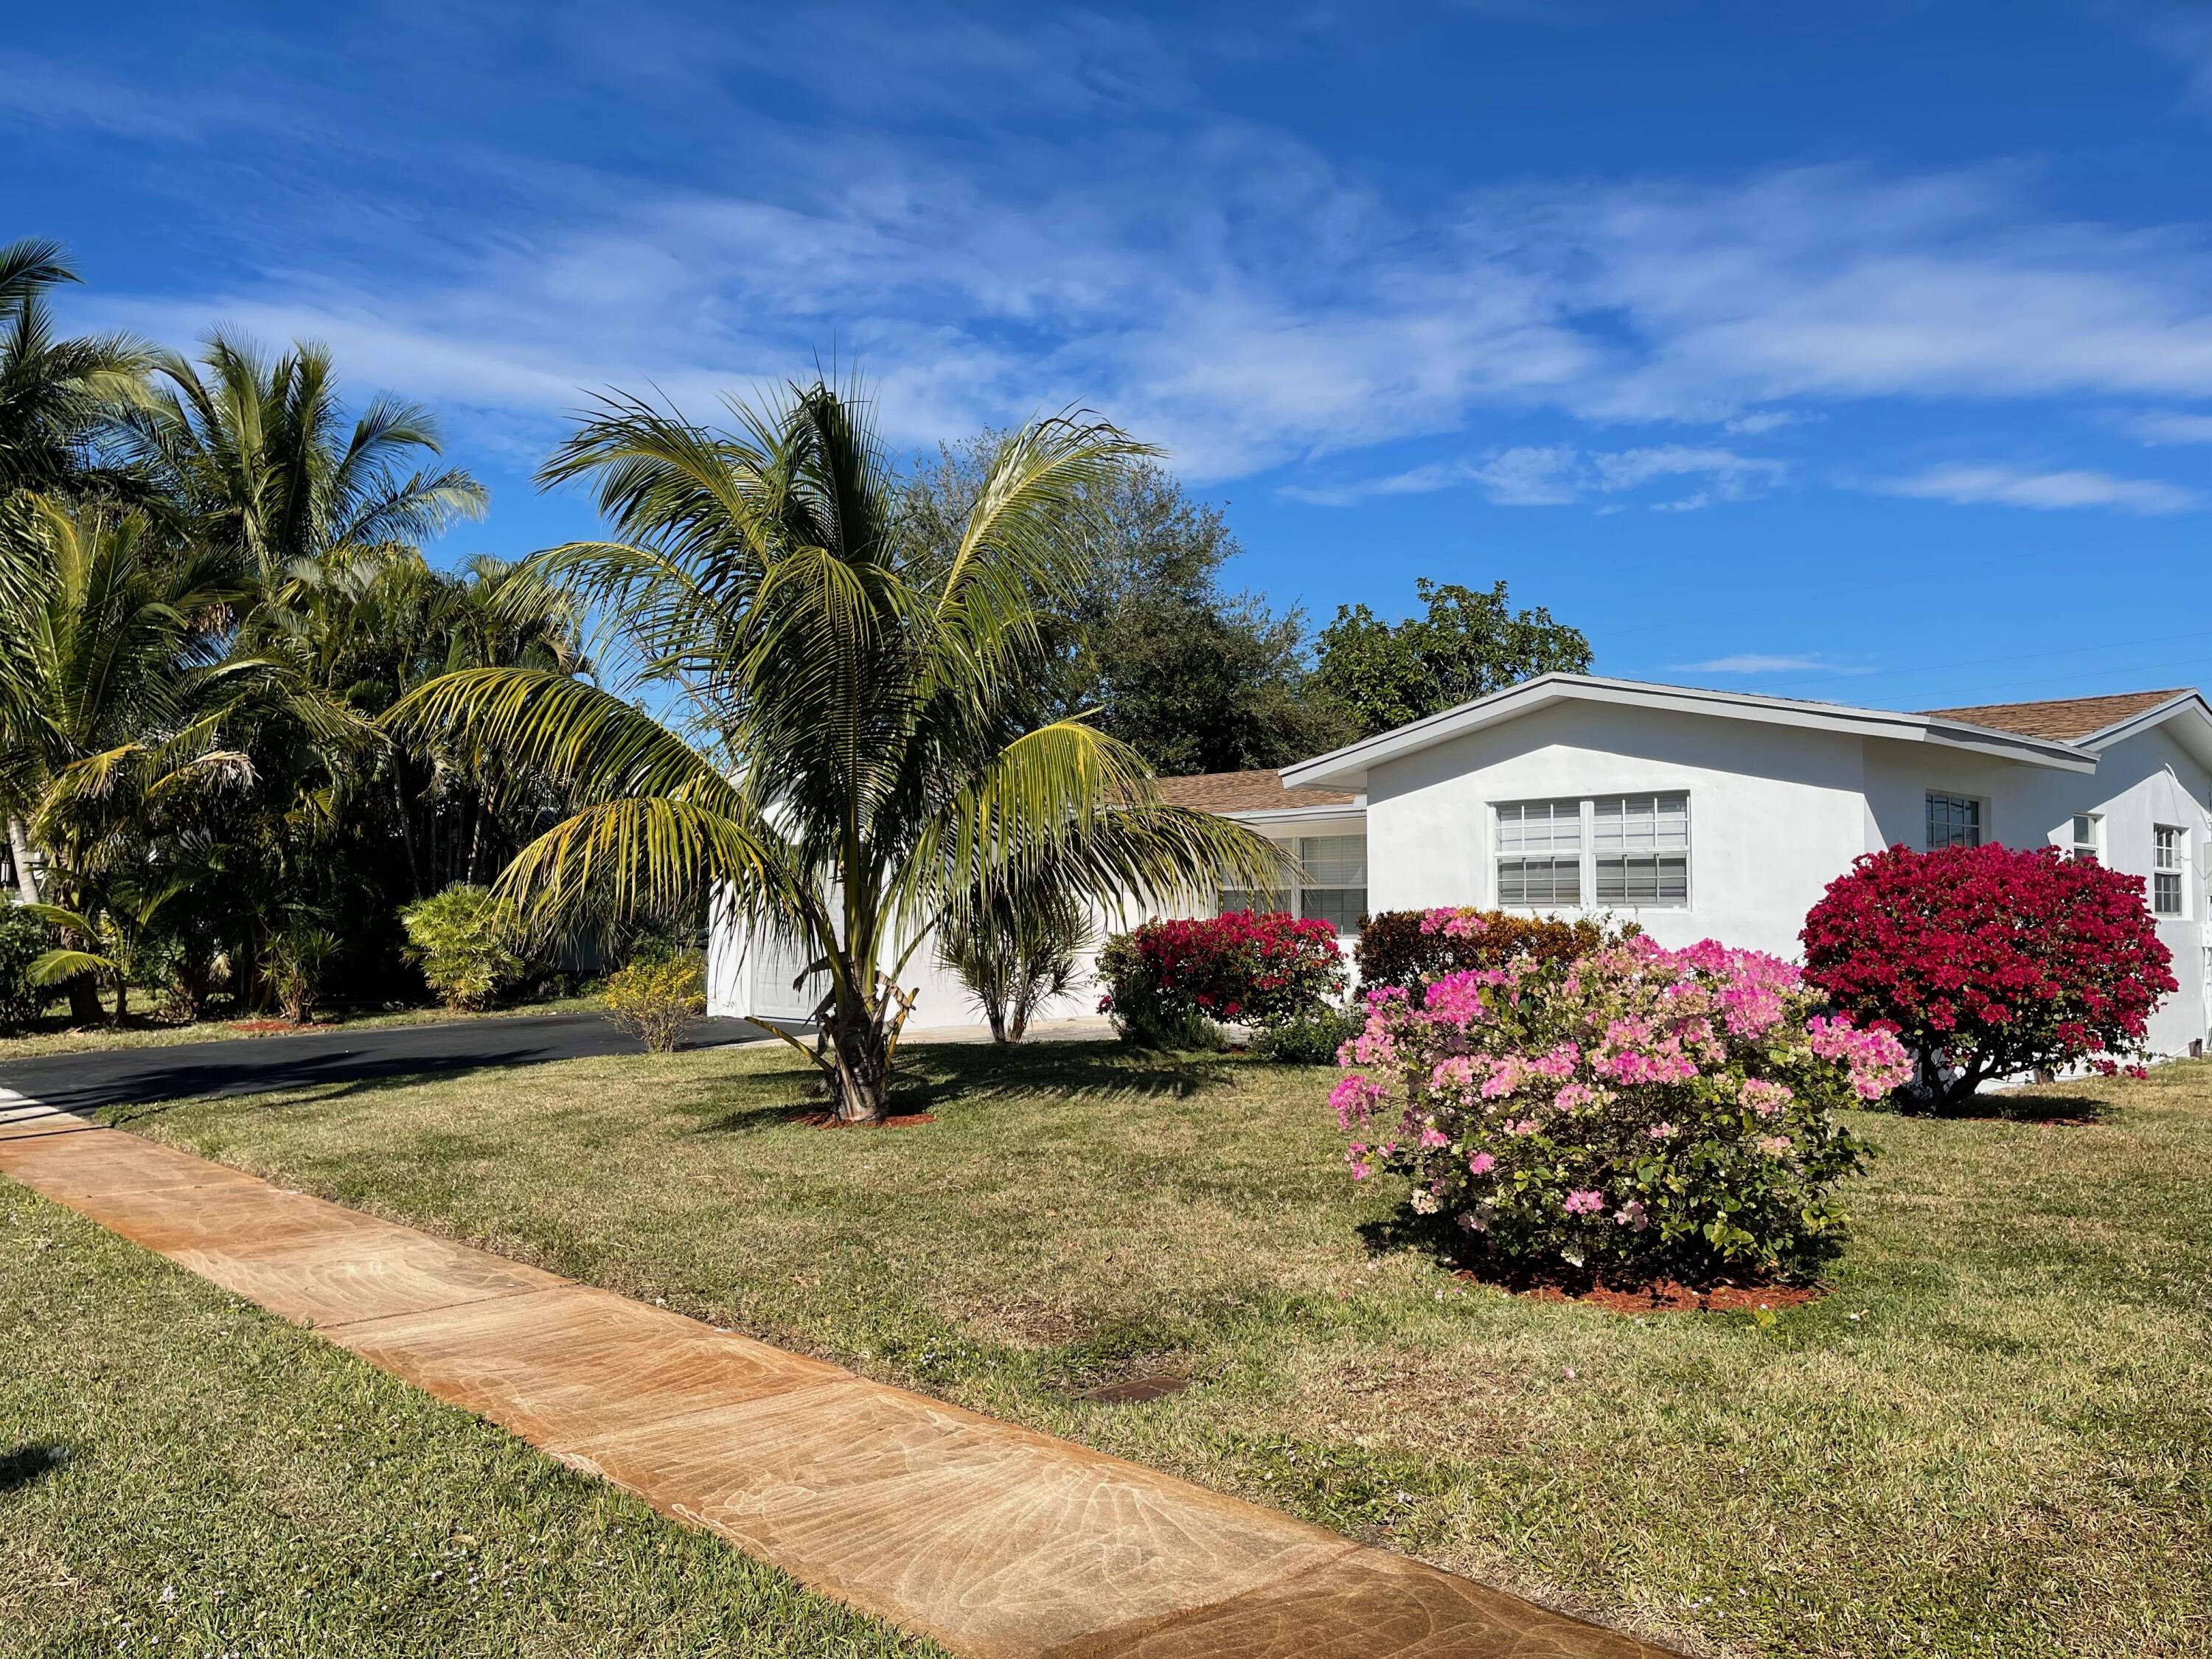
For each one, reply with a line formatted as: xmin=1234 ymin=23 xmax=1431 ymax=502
xmin=1803 ymin=845 xmax=2174 ymax=1110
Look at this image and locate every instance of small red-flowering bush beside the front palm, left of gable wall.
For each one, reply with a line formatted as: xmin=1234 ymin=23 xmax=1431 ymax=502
xmin=1099 ymin=911 xmax=1345 ymax=1046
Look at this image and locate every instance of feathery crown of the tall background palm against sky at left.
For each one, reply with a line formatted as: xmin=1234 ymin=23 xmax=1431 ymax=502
xmin=122 ymin=332 xmax=487 ymax=586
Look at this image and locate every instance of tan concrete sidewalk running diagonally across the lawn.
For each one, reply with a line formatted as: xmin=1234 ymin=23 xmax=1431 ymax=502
xmin=0 ymin=1102 xmax=1661 ymax=1659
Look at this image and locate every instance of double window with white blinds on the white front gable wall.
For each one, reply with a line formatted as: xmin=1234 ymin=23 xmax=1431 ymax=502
xmin=1498 ymin=794 xmax=1690 ymax=909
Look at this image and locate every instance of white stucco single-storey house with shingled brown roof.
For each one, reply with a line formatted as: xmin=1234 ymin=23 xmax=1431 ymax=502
xmin=712 ymin=675 xmax=2212 ymax=1053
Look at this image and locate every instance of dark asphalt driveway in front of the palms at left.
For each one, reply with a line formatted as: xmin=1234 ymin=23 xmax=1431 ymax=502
xmin=0 ymin=1013 xmax=768 ymax=1113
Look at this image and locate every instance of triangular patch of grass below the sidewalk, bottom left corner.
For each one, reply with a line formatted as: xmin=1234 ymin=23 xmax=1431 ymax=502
xmin=0 ymin=1183 xmax=942 ymax=1659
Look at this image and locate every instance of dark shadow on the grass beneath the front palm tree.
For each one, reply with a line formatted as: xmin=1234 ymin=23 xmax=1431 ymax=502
xmin=677 ymin=1042 xmax=1243 ymax=1135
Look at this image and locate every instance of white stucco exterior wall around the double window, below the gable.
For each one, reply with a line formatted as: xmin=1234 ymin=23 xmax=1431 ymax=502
xmin=1367 ymin=703 xmax=2212 ymax=1053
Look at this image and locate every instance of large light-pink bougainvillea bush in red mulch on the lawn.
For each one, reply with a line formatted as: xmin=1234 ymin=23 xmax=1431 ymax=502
xmin=1332 ymin=938 xmax=1909 ymax=1283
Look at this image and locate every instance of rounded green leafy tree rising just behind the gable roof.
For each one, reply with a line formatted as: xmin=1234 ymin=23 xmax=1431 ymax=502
xmin=1314 ymin=577 xmax=1590 ymax=737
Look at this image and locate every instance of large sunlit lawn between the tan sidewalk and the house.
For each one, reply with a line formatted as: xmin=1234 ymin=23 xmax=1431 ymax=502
xmin=17 ymin=1044 xmax=2212 ymax=1659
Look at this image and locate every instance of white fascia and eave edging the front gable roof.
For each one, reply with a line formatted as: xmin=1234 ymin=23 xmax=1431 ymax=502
xmin=1283 ymin=675 xmax=2106 ymax=790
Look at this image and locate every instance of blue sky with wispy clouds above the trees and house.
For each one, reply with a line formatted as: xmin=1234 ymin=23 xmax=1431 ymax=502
xmin=0 ymin=0 xmax=2212 ymax=708
